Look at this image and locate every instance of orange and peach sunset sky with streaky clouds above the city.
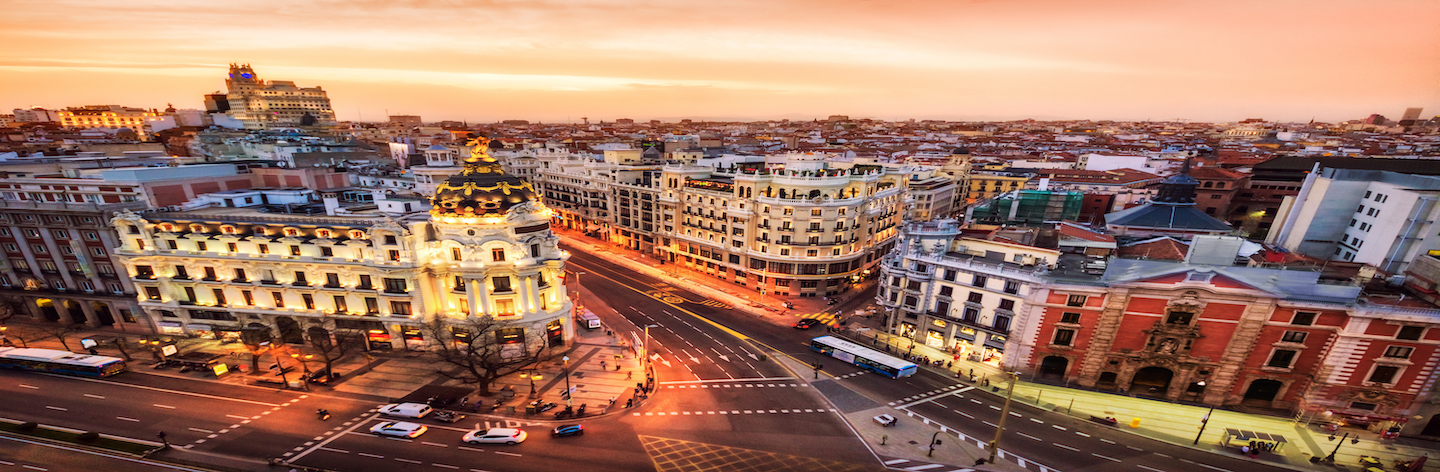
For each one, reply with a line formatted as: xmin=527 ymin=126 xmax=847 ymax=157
xmin=0 ymin=0 xmax=1440 ymax=122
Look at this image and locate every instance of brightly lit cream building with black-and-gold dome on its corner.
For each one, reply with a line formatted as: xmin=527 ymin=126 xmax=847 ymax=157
xmin=112 ymin=145 xmax=573 ymax=350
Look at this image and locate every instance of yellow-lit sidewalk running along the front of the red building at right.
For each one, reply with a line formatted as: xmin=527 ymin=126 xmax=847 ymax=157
xmin=841 ymin=309 xmax=1440 ymax=471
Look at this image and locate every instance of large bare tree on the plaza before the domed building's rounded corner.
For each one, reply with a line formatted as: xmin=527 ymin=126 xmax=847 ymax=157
xmin=425 ymin=317 xmax=554 ymax=396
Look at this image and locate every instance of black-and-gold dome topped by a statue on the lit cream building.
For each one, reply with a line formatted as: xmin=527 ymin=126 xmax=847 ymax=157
xmin=431 ymin=138 xmax=537 ymax=216
